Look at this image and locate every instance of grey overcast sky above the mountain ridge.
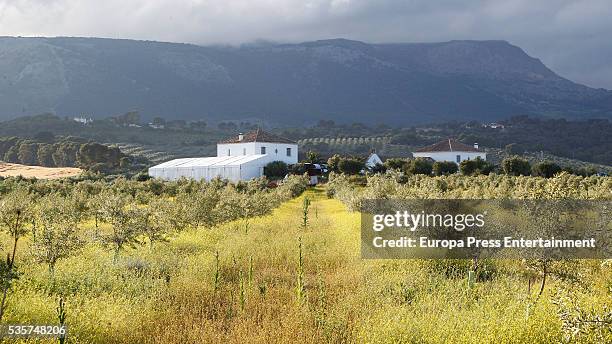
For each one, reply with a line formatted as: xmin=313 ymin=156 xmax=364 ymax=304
xmin=0 ymin=0 xmax=612 ymax=89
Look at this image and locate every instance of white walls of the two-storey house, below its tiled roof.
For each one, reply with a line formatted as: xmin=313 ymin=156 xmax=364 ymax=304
xmin=217 ymin=142 xmax=298 ymax=165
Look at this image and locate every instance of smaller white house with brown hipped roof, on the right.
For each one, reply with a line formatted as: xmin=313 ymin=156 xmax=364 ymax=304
xmin=412 ymin=139 xmax=487 ymax=163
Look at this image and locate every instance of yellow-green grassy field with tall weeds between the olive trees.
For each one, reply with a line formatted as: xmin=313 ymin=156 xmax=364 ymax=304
xmin=3 ymin=189 xmax=612 ymax=344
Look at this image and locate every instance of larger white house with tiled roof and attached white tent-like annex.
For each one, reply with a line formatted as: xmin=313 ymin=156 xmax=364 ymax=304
xmin=149 ymin=129 xmax=298 ymax=182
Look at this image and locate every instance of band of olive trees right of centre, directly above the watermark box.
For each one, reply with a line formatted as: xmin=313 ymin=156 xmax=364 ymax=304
xmin=327 ymin=170 xmax=612 ymax=210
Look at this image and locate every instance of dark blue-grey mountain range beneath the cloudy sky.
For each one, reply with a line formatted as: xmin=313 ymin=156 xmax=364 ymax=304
xmin=0 ymin=37 xmax=612 ymax=124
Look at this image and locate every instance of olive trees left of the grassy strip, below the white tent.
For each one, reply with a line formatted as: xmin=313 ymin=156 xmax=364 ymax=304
xmin=0 ymin=176 xmax=307 ymax=320
